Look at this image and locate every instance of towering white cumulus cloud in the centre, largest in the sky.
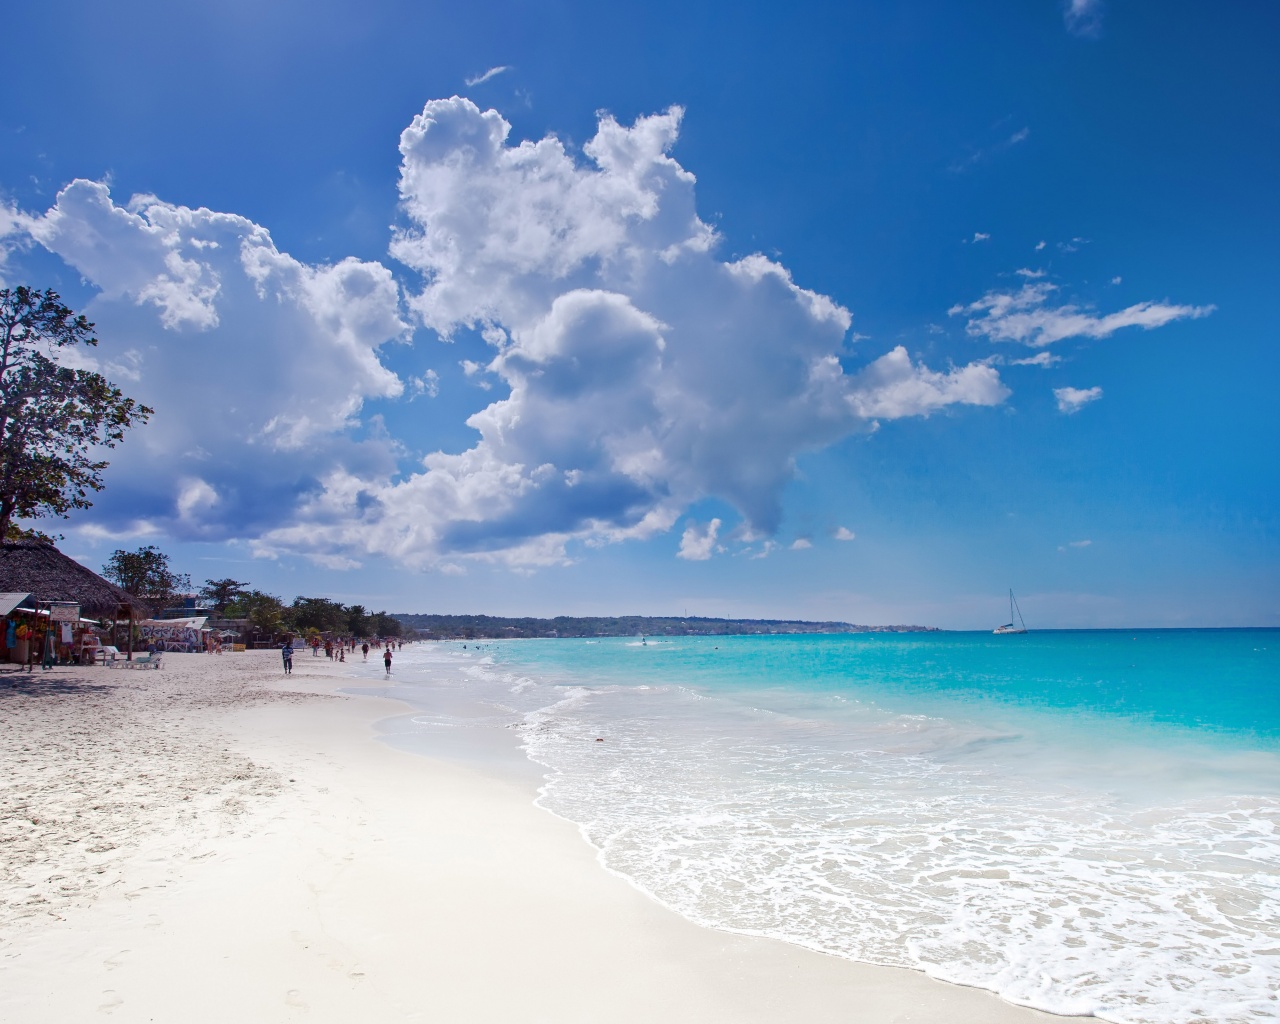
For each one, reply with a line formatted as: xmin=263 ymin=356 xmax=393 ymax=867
xmin=254 ymin=97 xmax=1007 ymax=564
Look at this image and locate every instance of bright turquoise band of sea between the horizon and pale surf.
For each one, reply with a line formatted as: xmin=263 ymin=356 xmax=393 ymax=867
xmin=486 ymin=630 xmax=1280 ymax=744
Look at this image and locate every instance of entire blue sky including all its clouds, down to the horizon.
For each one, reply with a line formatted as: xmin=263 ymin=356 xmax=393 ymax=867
xmin=0 ymin=0 xmax=1280 ymax=627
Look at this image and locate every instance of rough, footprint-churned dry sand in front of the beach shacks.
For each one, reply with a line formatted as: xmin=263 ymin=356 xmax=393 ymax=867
xmin=0 ymin=655 xmax=333 ymax=942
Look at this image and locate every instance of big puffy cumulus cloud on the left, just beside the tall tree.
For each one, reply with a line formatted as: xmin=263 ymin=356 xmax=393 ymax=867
xmin=23 ymin=180 xmax=407 ymax=538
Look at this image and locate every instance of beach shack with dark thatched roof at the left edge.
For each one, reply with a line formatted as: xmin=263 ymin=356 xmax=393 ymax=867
xmin=0 ymin=540 xmax=151 ymax=664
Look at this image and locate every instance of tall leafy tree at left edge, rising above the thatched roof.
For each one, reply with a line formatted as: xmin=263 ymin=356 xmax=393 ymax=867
xmin=0 ymin=285 xmax=155 ymax=536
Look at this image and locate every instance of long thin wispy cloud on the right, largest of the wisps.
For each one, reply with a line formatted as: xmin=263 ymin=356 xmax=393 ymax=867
xmin=947 ymin=282 xmax=1216 ymax=348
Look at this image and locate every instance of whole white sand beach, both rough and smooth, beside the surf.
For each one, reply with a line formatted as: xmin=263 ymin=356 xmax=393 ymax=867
xmin=0 ymin=652 xmax=1059 ymax=1024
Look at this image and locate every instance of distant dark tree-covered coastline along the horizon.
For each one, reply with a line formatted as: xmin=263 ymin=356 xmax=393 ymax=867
xmin=392 ymin=612 xmax=941 ymax=640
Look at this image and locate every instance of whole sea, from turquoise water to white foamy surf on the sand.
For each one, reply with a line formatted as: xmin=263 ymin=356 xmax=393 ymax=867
xmin=373 ymin=630 xmax=1280 ymax=1024
